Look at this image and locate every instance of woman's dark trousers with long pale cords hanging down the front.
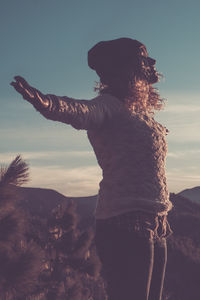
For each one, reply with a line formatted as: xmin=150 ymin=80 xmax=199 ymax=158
xmin=95 ymin=213 xmax=171 ymax=300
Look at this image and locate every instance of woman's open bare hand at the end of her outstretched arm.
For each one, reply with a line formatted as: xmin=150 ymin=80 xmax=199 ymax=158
xmin=10 ymin=76 xmax=49 ymax=107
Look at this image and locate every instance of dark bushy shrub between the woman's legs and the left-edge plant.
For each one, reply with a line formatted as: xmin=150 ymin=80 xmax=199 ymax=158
xmin=28 ymin=202 xmax=100 ymax=300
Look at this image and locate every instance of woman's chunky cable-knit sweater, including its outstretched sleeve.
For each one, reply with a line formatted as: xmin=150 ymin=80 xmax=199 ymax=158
xmin=33 ymin=94 xmax=172 ymax=219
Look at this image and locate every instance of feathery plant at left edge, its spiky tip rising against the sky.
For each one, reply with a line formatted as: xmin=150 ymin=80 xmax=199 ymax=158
xmin=0 ymin=155 xmax=42 ymax=300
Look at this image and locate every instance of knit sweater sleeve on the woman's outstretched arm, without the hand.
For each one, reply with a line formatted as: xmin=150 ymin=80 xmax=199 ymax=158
xmin=35 ymin=94 xmax=122 ymax=130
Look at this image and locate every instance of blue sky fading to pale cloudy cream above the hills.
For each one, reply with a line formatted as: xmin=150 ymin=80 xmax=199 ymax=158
xmin=0 ymin=0 xmax=200 ymax=196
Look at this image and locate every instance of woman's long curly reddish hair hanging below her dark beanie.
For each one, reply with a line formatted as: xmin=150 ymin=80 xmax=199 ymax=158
xmin=94 ymin=72 xmax=165 ymax=115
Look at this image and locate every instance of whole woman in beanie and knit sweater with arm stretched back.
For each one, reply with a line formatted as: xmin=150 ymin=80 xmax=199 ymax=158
xmin=11 ymin=38 xmax=172 ymax=300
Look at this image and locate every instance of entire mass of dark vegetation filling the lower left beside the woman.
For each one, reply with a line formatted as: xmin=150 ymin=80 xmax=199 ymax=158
xmin=0 ymin=156 xmax=102 ymax=300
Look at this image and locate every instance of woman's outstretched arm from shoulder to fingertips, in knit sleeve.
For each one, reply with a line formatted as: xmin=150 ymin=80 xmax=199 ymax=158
xmin=11 ymin=76 xmax=122 ymax=129
